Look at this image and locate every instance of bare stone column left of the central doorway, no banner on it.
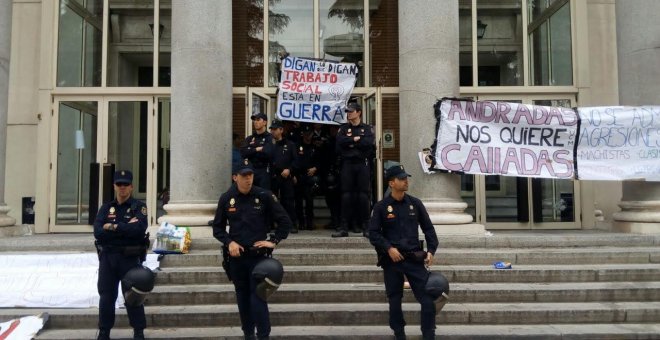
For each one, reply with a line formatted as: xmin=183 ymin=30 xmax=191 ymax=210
xmin=159 ymin=0 xmax=232 ymax=236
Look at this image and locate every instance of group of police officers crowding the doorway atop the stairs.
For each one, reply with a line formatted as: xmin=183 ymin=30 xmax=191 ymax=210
xmin=240 ymin=103 xmax=375 ymax=237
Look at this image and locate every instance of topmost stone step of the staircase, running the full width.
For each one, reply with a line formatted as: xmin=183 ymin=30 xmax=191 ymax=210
xmin=5 ymin=231 xmax=660 ymax=252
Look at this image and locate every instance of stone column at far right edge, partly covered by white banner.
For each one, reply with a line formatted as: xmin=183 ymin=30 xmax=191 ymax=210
xmin=613 ymin=0 xmax=660 ymax=233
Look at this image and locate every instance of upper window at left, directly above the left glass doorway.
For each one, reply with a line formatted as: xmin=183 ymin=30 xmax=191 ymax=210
xmin=56 ymin=0 xmax=172 ymax=87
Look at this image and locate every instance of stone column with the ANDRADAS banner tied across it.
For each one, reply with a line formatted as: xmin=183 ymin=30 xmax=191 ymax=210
xmin=399 ymin=0 xmax=484 ymax=234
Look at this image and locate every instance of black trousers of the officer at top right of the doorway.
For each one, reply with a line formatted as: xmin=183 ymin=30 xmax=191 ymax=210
xmin=340 ymin=159 xmax=371 ymax=231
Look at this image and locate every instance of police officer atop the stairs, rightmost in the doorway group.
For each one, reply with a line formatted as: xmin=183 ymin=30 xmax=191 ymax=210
xmin=332 ymin=103 xmax=375 ymax=237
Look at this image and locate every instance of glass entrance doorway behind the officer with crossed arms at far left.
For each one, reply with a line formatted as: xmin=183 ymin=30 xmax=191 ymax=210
xmin=49 ymin=96 xmax=170 ymax=232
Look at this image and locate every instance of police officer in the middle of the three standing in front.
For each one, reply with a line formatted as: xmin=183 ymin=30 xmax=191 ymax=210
xmin=213 ymin=160 xmax=291 ymax=339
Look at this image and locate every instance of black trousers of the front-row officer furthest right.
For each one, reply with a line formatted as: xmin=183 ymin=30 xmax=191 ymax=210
xmin=383 ymin=255 xmax=435 ymax=339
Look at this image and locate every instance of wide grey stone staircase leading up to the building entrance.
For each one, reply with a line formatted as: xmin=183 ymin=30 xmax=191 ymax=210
xmin=0 ymin=231 xmax=660 ymax=339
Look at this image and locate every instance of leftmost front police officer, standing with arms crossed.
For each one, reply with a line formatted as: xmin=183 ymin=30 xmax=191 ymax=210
xmin=94 ymin=170 xmax=147 ymax=340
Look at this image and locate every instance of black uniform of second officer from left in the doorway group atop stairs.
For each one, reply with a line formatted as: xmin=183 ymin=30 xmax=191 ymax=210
xmin=271 ymin=138 xmax=296 ymax=231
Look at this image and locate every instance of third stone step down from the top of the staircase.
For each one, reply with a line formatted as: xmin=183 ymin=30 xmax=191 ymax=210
xmin=156 ymin=264 xmax=660 ymax=285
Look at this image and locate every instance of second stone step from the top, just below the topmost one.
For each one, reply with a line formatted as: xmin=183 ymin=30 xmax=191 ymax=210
xmin=156 ymin=247 xmax=660 ymax=267
